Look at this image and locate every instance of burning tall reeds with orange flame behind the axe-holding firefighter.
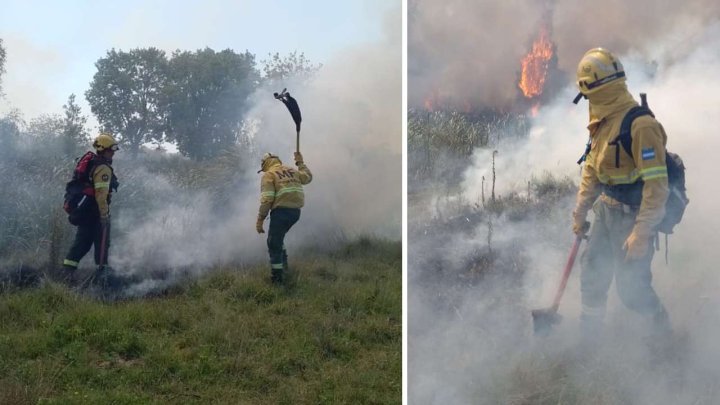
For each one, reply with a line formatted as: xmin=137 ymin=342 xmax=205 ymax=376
xmin=408 ymin=25 xmax=563 ymax=188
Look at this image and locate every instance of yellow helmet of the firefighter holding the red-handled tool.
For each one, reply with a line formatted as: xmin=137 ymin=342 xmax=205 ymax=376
xmin=577 ymin=48 xmax=625 ymax=96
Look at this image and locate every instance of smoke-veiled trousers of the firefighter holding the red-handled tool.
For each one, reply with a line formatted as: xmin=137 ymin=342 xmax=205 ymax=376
xmin=580 ymin=200 xmax=669 ymax=333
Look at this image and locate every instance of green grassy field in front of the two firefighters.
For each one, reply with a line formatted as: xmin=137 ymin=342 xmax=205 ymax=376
xmin=0 ymin=239 xmax=402 ymax=404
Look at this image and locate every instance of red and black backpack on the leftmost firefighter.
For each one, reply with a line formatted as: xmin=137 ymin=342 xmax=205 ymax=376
xmin=63 ymin=152 xmax=99 ymax=226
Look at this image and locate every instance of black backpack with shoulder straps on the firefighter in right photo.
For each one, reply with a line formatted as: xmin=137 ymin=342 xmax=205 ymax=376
xmin=578 ymin=93 xmax=690 ymax=235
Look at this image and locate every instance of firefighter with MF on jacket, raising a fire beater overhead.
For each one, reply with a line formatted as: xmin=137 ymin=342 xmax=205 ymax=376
xmin=255 ymin=152 xmax=312 ymax=284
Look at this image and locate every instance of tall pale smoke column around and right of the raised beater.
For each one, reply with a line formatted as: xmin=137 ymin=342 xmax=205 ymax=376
xmin=250 ymin=5 xmax=402 ymax=239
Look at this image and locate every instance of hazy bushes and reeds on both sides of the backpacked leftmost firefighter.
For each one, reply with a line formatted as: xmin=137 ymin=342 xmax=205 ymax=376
xmin=0 ymin=141 xmax=254 ymax=267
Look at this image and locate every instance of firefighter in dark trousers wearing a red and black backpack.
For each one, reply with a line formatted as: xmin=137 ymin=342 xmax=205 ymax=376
xmin=63 ymin=133 xmax=119 ymax=283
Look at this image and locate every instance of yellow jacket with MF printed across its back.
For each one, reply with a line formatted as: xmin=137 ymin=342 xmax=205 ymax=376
xmin=258 ymin=157 xmax=312 ymax=221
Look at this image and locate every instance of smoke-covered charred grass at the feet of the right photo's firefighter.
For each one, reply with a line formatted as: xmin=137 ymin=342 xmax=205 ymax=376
xmin=408 ymin=175 xmax=720 ymax=405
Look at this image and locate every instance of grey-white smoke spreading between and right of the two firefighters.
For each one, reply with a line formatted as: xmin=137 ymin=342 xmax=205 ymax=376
xmin=112 ymin=4 xmax=402 ymax=288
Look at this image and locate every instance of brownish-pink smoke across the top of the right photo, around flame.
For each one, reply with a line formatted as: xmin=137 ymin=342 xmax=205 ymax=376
xmin=408 ymin=0 xmax=720 ymax=108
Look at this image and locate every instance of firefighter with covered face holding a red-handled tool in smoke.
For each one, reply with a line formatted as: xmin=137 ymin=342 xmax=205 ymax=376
xmin=573 ymin=48 xmax=671 ymax=339
